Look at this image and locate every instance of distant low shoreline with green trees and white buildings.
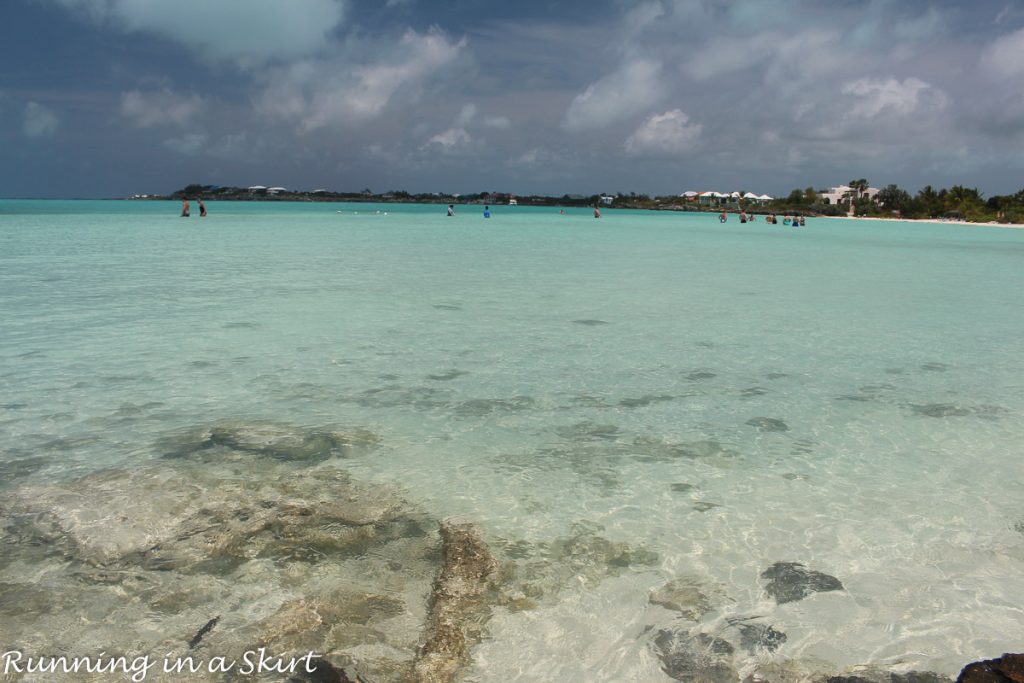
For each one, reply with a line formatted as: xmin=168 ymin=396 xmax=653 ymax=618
xmin=142 ymin=178 xmax=1024 ymax=224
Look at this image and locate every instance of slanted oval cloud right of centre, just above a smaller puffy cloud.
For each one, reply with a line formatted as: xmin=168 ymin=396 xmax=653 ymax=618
xmin=562 ymin=59 xmax=665 ymax=133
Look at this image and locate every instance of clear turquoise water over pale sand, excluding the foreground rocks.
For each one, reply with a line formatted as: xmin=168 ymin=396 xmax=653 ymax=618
xmin=0 ymin=201 xmax=1024 ymax=681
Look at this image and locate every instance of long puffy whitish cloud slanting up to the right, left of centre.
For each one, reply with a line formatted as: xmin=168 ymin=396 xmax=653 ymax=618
xmin=257 ymin=30 xmax=466 ymax=132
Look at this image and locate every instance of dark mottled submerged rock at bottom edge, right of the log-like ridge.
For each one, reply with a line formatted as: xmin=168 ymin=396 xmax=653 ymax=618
xmin=654 ymin=629 xmax=739 ymax=683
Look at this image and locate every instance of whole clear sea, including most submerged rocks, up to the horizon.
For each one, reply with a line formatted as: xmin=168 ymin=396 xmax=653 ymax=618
xmin=0 ymin=200 xmax=1024 ymax=683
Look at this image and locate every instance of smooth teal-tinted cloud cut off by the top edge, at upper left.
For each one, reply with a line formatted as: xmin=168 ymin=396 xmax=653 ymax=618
xmin=51 ymin=0 xmax=344 ymax=65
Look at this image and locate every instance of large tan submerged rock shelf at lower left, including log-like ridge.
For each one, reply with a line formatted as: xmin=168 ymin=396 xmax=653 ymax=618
xmin=0 ymin=432 xmax=503 ymax=683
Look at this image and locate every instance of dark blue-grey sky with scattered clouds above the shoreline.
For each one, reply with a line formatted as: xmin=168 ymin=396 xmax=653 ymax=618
xmin=0 ymin=0 xmax=1024 ymax=198
